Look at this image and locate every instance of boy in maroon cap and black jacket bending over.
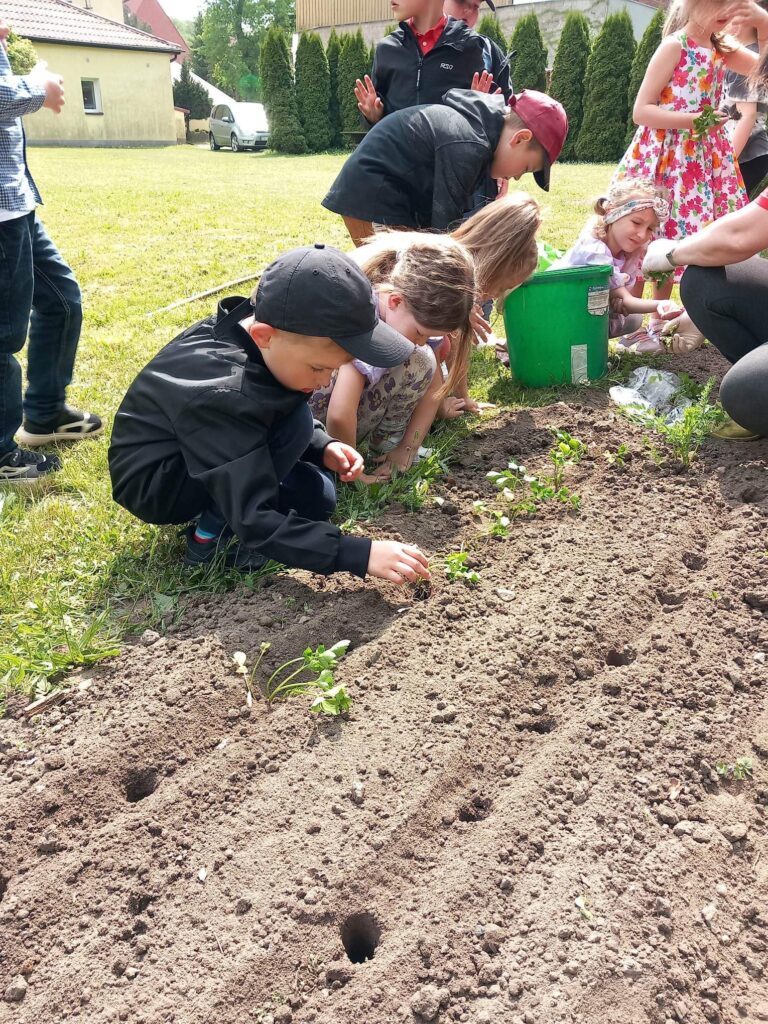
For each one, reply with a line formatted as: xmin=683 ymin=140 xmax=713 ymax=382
xmin=323 ymin=89 xmax=568 ymax=245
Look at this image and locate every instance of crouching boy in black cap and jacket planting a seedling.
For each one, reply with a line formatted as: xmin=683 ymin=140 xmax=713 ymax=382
xmin=110 ymin=245 xmax=429 ymax=583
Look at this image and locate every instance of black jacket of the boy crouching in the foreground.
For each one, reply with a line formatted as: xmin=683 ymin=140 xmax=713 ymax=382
xmin=110 ymin=296 xmax=371 ymax=577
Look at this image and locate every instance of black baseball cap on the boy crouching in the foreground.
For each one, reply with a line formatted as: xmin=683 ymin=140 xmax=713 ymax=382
xmin=252 ymin=242 xmax=416 ymax=367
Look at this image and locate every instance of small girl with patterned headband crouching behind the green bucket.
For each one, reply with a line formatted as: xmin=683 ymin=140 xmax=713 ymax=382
xmin=549 ymin=178 xmax=682 ymax=352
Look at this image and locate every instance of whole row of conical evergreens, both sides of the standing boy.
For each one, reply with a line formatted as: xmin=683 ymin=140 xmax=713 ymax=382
xmin=261 ymin=8 xmax=664 ymax=163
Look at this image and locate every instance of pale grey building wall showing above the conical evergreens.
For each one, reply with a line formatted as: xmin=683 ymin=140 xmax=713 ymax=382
xmin=313 ymin=0 xmax=655 ymax=59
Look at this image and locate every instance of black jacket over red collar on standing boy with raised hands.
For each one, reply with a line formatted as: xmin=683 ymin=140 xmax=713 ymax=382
xmin=371 ymin=17 xmax=509 ymax=115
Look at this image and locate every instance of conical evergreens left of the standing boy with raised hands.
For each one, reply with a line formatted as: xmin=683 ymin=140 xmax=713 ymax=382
xmin=261 ymin=26 xmax=373 ymax=153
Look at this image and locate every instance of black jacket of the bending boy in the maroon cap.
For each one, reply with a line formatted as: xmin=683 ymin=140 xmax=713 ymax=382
xmin=323 ymin=89 xmax=507 ymax=231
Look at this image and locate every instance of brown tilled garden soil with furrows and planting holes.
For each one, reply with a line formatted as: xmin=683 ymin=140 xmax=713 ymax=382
xmin=0 ymin=352 xmax=768 ymax=1024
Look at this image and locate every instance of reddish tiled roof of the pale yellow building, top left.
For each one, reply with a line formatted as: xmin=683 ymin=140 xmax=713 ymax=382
xmin=2 ymin=0 xmax=179 ymax=53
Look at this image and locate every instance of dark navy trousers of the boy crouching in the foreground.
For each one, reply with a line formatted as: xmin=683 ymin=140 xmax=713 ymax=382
xmin=200 ymin=402 xmax=336 ymax=535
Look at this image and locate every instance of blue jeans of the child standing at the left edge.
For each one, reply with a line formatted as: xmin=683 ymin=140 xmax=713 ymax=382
xmin=0 ymin=212 xmax=83 ymax=456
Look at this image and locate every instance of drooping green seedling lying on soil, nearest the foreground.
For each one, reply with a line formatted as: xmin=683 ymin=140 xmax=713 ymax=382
xmin=232 ymin=640 xmax=352 ymax=716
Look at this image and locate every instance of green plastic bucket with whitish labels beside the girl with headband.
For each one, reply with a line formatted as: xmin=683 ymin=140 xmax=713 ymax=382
xmin=504 ymin=266 xmax=612 ymax=387
